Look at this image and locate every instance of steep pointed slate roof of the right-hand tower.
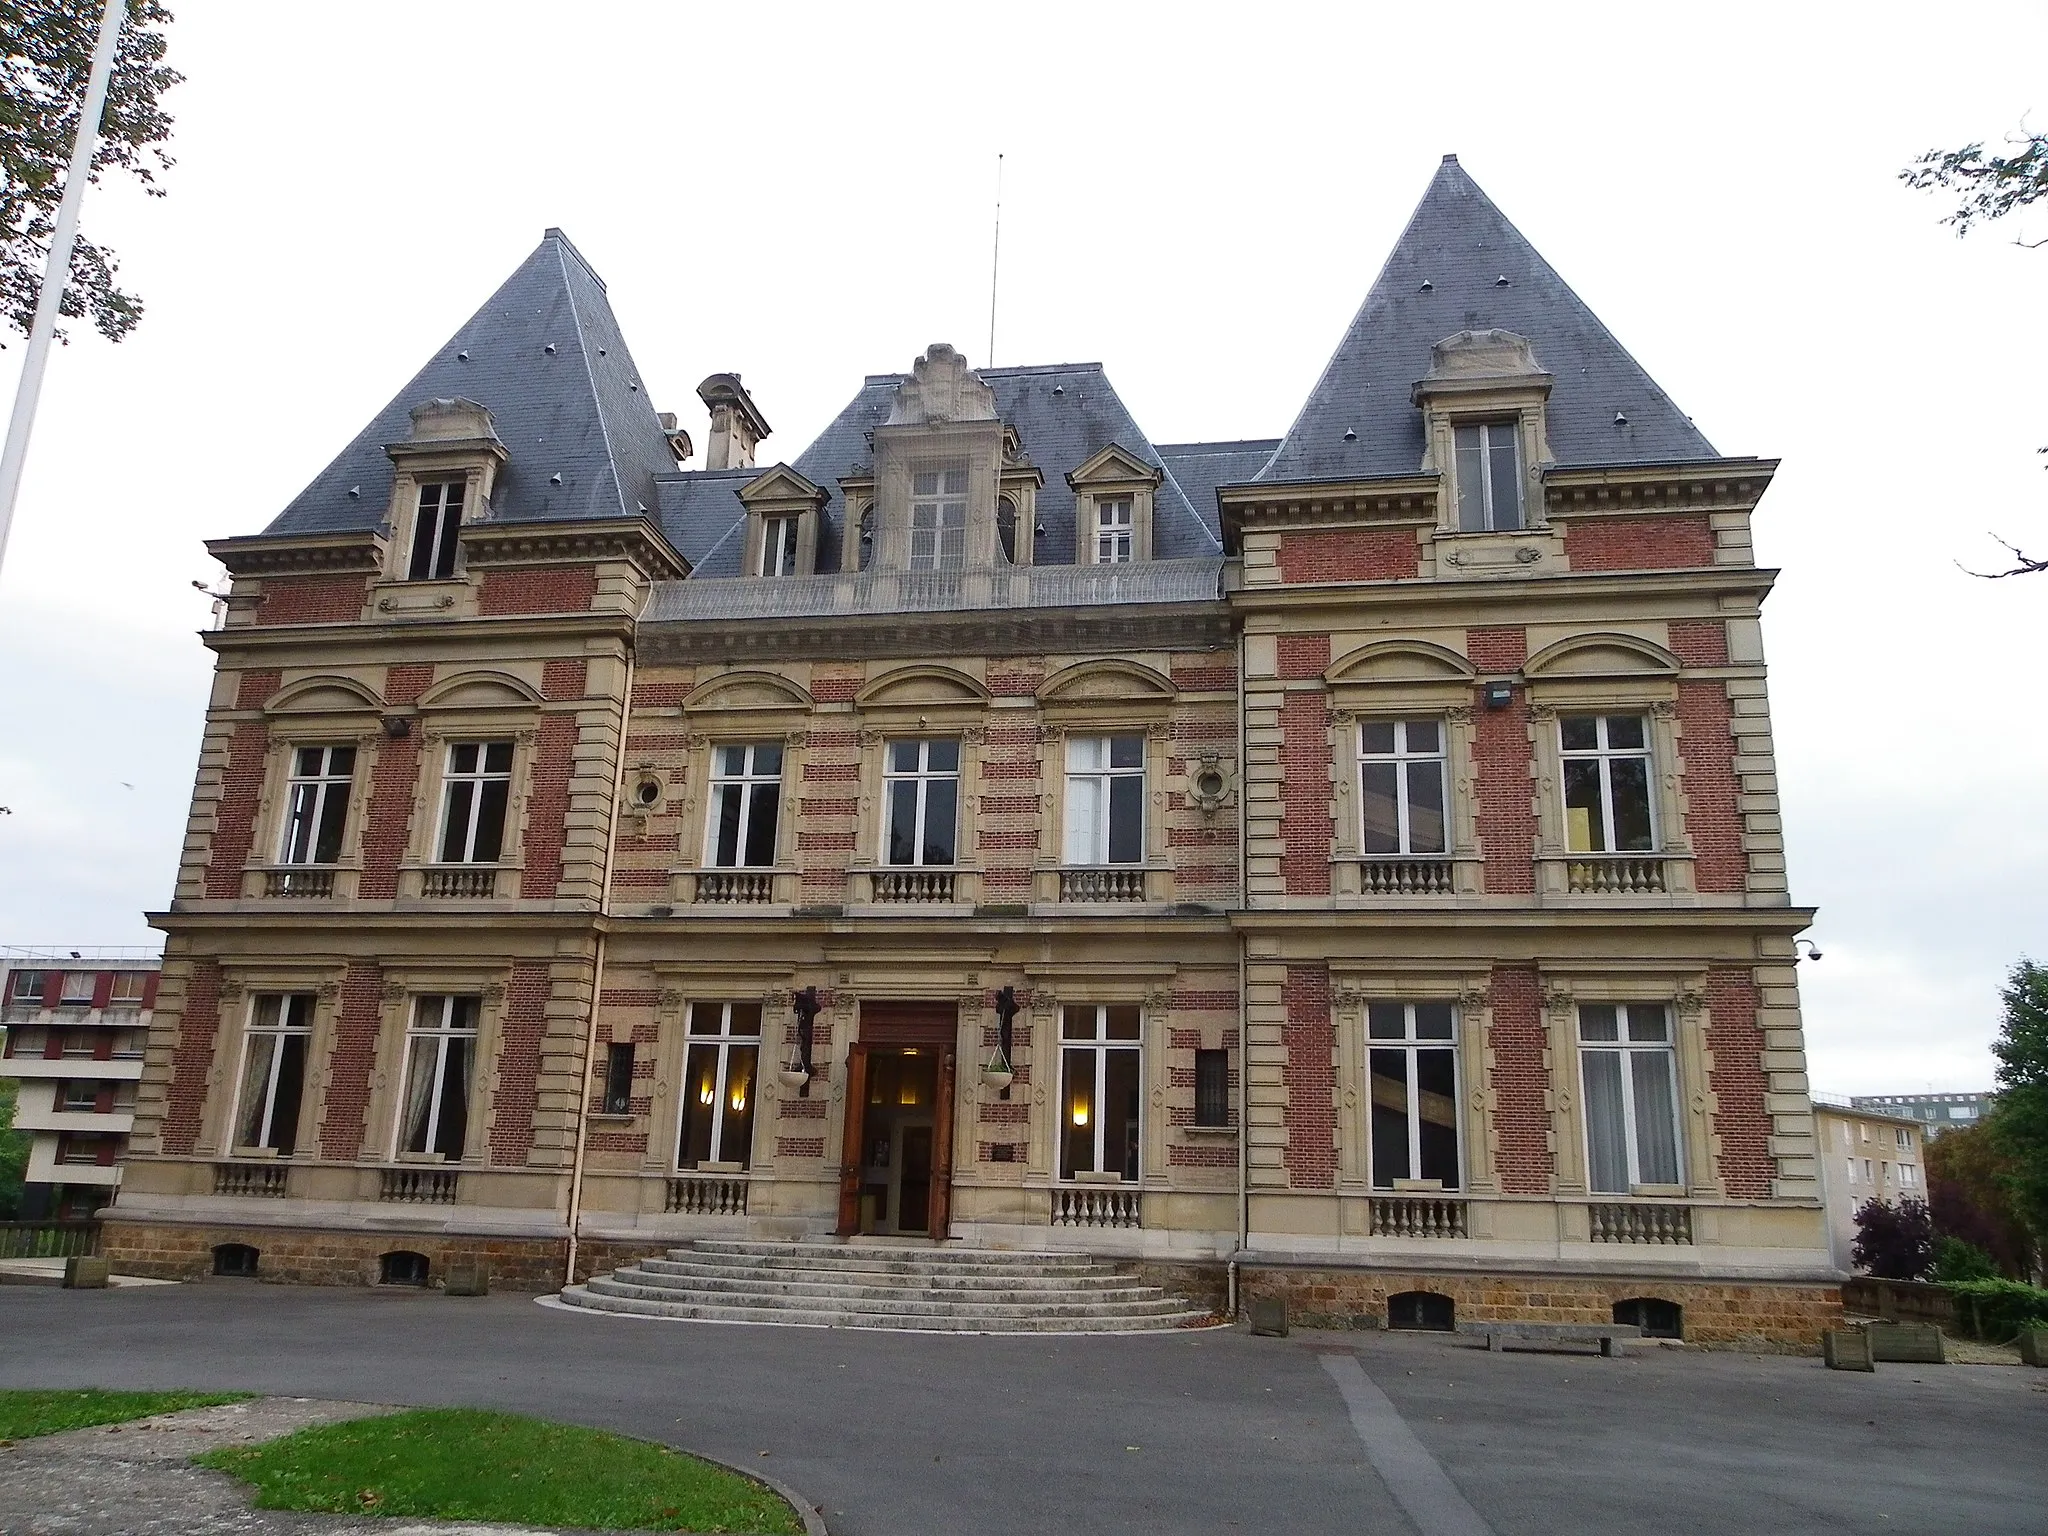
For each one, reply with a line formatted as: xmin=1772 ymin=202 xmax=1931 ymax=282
xmin=1255 ymin=156 xmax=1718 ymax=481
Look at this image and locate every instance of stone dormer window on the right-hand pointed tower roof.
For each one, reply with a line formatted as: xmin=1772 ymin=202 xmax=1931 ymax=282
xmin=1413 ymin=330 xmax=1550 ymax=532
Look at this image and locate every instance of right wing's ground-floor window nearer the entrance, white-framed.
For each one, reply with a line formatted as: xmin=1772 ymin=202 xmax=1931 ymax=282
xmin=1366 ymin=1004 xmax=1462 ymax=1190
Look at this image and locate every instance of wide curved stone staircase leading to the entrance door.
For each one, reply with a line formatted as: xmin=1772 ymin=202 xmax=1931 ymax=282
xmin=561 ymin=1239 xmax=1208 ymax=1333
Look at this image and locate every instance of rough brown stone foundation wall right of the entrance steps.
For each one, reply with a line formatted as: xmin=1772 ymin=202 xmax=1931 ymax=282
xmin=1237 ymin=1266 xmax=1841 ymax=1354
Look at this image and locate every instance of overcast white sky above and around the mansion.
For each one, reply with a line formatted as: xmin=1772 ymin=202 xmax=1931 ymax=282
xmin=0 ymin=0 xmax=2048 ymax=1092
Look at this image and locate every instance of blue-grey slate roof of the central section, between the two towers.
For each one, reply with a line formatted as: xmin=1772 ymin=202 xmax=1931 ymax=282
xmin=662 ymin=362 xmax=1212 ymax=580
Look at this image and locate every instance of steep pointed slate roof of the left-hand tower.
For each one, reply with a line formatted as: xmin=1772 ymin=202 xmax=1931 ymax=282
xmin=264 ymin=229 xmax=676 ymax=535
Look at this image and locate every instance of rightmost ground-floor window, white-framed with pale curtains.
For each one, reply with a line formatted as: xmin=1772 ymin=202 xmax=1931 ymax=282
xmin=1579 ymin=1004 xmax=1683 ymax=1194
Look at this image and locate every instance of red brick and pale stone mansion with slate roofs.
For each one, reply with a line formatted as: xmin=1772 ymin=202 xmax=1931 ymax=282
xmin=109 ymin=160 xmax=1837 ymax=1341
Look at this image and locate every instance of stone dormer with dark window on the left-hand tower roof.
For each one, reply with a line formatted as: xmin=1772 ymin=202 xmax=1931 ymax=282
xmin=385 ymin=395 xmax=510 ymax=582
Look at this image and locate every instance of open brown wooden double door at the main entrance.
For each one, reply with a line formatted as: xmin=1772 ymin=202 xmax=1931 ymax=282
xmin=838 ymin=1004 xmax=961 ymax=1243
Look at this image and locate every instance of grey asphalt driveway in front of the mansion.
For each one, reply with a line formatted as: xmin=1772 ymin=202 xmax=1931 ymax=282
xmin=0 ymin=1282 xmax=2048 ymax=1536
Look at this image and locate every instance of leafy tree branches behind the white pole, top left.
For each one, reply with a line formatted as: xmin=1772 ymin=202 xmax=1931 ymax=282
xmin=0 ymin=0 xmax=184 ymax=342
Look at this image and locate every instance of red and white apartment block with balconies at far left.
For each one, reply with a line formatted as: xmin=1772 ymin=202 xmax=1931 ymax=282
xmin=0 ymin=946 xmax=160 ymax=1221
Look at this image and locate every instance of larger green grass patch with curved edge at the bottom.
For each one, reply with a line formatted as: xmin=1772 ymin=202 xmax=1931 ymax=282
xmin=195 ymin=1409 xmax=803 ymax=1536
